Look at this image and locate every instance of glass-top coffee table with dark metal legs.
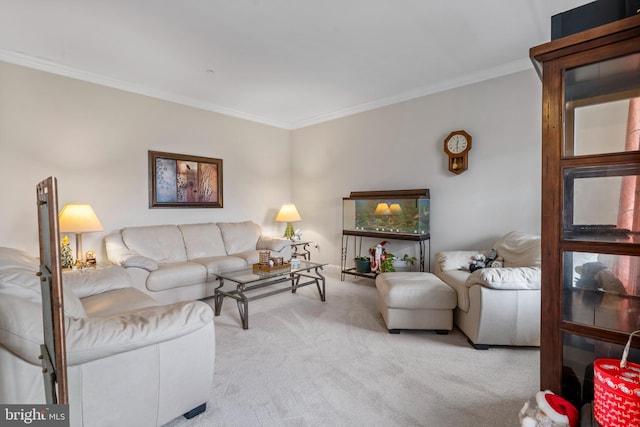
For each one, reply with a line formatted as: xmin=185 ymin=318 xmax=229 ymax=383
xmin=214 ymin=260 xmax=326 ymax=329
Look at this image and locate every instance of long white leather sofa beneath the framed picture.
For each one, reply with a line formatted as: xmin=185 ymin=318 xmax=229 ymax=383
xmin=105 ymin=221 xmax=291 ymax=303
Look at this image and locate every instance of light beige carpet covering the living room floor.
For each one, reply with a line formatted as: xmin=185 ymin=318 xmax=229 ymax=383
xmin=162 ymin=269 xmax=539 ymax=427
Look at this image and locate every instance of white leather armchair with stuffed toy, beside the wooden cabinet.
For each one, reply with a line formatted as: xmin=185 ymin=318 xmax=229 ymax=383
xmin=435 ymin=231 xmax=541 ymax=349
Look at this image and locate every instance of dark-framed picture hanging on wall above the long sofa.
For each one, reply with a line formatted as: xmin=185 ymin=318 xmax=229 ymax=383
xmin=149 ymin=150 xmax=222 ymax=208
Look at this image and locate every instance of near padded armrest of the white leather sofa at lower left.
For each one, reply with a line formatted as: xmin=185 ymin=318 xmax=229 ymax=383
xmin=65 ymin=301 xmax=213 ymax=365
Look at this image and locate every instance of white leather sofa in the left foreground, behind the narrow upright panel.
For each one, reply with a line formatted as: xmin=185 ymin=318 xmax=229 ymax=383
xmin=0 ymin=248 xmax=215 ymax=427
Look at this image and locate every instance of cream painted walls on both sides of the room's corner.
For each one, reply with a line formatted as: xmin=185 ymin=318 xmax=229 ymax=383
xmin=0 ymin=62 xmax=541 ymax=270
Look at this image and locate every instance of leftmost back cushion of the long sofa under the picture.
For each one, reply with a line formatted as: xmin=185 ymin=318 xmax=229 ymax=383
xmin=122 ymin=225 xmax=187 ymax=262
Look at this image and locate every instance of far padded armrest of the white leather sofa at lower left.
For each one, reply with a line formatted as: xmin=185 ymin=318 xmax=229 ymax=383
xmin=62 ymin=266 xmax=131 ymax=298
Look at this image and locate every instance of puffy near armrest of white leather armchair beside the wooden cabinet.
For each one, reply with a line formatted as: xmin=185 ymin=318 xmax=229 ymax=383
xmin=466 ymin=267 xmax=541 ymax=290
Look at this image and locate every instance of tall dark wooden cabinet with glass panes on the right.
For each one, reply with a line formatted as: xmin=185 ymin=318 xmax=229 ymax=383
xmin=530 ymin=16 xmax=640 ymax=407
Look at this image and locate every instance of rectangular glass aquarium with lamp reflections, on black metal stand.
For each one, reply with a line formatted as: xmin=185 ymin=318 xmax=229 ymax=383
xmin=342 ymin=189 xmax=430 ymax=236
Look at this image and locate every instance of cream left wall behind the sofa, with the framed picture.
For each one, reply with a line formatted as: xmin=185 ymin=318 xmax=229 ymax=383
xmin=0 ymin=62 xmax=290 ymax=262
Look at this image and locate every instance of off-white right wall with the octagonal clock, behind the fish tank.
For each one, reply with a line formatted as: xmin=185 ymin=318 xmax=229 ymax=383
xmin=292 ymin=70 xmax=542 ymax=266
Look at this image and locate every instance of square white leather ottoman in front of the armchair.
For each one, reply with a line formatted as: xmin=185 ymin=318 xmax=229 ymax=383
xmin=376 ymin=272 xmax=458 ymax=334
